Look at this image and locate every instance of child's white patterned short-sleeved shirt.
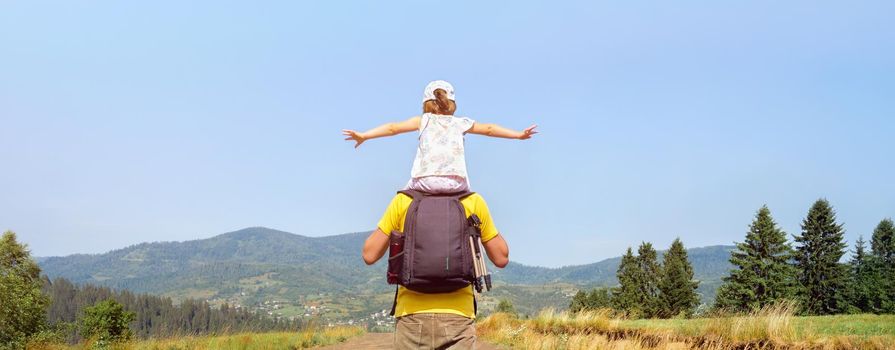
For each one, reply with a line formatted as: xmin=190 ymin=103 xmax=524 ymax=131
xmin=410 ymin=113 xmax=475 ymax=179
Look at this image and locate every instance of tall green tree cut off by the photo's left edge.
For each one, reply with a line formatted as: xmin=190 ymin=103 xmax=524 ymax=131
xmin=0 ymin=231 xmax=50 ymax=349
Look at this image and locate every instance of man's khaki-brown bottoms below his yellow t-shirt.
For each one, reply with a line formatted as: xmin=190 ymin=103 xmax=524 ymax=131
xmin=395 ymin=313 xmax=475 ymax=350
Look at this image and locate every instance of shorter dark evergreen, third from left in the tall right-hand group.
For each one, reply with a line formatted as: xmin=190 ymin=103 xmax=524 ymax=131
xmin=848 ymin=237 xmax=886 ymax=313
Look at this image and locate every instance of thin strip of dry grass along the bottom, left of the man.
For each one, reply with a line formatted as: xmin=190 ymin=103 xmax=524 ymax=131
xmin=28 ymin=327 xmax=365 ymax=350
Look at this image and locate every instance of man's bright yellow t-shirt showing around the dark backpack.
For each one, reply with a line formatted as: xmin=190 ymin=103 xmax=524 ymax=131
xmin=379 ymin=193 xmax=498 ymax=318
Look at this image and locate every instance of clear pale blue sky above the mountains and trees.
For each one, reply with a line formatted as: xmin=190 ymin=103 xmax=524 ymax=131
xmin=0 ymin=1 xmax=895 ymax=266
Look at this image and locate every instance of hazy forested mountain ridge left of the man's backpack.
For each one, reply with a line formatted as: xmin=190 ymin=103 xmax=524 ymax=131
xmin=39 ymin=227 xmax=384 ymax=299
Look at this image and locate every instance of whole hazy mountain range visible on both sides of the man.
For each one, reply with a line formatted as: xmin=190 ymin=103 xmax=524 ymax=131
xmin=38 ymin=227 xmax=733 ymax=318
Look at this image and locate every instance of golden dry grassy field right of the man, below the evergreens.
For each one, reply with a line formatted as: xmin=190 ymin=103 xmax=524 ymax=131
xmin=478 ymin=306 xmax=895 ymax=350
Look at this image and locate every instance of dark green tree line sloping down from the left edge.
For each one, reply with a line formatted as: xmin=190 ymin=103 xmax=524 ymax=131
xmin=0 ymin=231 xmax=303 ymax=349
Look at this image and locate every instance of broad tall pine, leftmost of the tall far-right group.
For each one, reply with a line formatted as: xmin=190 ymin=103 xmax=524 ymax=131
xmin=715 ymin=205 xmax=796 ymax=312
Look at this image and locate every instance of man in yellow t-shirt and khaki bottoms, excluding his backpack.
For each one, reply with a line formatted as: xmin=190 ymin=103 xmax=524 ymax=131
xmin=362 ymin=193 xmax=509 ymax=349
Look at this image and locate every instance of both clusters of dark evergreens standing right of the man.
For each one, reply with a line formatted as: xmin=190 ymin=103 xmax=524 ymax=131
xmin=569 ymin=199 xmax=895 ymax=318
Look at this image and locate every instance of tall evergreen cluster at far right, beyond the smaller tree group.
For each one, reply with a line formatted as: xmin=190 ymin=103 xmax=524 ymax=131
xmin=714 ymin=199 xmax=895 ymax=315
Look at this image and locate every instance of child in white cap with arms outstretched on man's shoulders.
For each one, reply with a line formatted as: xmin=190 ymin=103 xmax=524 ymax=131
xmin=342 ymin=80 xmax=538 ymax=194
